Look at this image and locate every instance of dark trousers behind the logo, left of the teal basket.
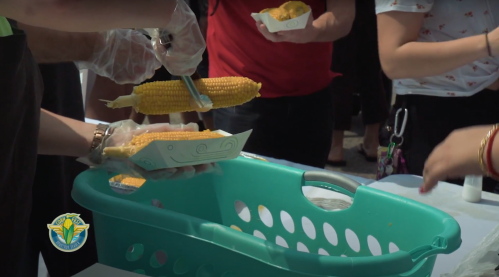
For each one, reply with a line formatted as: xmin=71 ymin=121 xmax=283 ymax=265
xmin=19 ymin=63 xmax=97 ymax=277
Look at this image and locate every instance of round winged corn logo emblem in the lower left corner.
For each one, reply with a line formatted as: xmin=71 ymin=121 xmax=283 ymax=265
xmin=47 ymin=214 xmax=90 ymax=252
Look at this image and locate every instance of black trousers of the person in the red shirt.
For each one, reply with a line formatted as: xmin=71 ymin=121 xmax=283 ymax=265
xmin=213 ymin=84 xmax=334 ymax=168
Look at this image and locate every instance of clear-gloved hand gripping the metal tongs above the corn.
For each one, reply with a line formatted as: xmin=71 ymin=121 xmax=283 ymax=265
xmin=145 ymin=0 xmax=206 ymax=76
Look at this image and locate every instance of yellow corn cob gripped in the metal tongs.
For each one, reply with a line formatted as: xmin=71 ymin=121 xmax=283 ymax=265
xmin=102 ymin=77 xmax=262 ymax=115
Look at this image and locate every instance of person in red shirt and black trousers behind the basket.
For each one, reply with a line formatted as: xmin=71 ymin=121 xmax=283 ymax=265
xmin=207 ymin=0 xmax=355 ymax=168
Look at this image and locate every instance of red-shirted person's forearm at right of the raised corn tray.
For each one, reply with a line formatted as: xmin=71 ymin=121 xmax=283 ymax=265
xmin=312 ymin=0 xmax=355 ymax=42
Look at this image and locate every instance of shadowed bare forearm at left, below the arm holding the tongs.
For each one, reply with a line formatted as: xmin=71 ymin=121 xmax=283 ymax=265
xmin=18 ymin=23 xmax=102 ymax=63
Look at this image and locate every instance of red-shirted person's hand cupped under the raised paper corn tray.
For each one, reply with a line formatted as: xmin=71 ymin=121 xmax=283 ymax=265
xmin=256 ymin=13 xmax=320 ymax=43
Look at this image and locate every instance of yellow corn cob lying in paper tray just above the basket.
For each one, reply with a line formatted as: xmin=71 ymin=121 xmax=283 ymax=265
xmin=103 ymin=130 xmax=223 ymax=158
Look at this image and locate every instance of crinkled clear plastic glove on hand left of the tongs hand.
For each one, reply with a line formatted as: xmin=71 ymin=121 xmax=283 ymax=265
xmin=76 ymin=29 xmax=161 ymax=84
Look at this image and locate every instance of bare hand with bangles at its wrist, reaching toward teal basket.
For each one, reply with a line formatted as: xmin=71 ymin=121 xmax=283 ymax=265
xmin=420 ymin=125 xmax=491 ymax=193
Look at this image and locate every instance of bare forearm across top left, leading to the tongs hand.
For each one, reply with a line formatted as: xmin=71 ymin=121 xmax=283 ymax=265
xmin=0 ymin=0 xmax=177 ymax=32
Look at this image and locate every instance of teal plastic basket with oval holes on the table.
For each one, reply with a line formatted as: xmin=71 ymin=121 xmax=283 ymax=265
xmin=72 ymin=157 xmax=461 ymax=277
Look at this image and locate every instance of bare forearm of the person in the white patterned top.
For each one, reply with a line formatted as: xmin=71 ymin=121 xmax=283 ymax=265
xmin=380 ymin=35 xmax=488 ymax=80
